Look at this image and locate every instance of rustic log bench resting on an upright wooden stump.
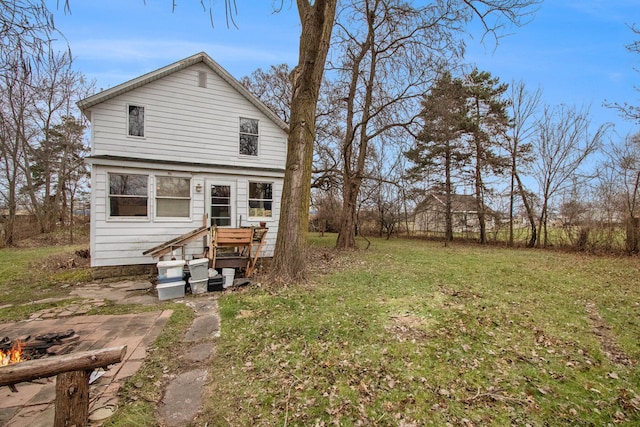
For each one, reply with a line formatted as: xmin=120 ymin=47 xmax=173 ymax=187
xmin=0 ymin=345 xmax=127 ymax=427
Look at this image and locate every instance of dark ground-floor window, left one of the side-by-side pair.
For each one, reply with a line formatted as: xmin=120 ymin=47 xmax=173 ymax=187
xmin=109 ymin=174 xmax=149 ymax=217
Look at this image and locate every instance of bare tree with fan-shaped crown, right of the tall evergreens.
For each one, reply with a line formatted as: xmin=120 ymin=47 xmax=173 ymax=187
xmin=533 ymin=105 xmax=609 ymax=247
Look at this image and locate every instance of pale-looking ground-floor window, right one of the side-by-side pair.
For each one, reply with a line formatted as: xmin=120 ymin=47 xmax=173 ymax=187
xmin=156 ymin=176 xmax=191 ymax=218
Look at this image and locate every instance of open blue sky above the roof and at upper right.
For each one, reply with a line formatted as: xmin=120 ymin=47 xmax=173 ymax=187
xmin=47 ymin=0 xmax=640 ymax=136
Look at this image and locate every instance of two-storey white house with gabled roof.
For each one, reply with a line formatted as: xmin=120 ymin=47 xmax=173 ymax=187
xmin=78 ymin=53 xmax=288 ymax=267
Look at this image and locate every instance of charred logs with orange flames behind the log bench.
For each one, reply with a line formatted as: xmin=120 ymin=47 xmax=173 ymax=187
xmin=0 ymin=329 xmax=80 ymax=363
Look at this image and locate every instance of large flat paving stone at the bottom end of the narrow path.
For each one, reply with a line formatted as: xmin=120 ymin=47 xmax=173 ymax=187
xmin=159 ymin=369 xmax=207 ymax=427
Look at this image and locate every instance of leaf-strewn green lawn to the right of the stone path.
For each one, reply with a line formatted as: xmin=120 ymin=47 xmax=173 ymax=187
xmin=198 ymin=236 xmax=640 ymax=426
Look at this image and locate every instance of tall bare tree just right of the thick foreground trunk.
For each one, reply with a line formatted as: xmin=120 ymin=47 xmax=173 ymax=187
xmin=331 ymin=0 xmax=464 ymax=248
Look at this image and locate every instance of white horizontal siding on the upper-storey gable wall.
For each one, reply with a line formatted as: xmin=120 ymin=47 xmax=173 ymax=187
xmin=86 ymin=63 xmax=286 ymax=169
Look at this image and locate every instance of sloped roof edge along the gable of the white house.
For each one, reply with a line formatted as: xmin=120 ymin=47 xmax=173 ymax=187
xmin=78 ymin=52 xmax=289 ymax=132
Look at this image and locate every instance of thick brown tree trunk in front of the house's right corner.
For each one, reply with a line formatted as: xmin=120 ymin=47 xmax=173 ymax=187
xmin=272 ymin=0 xmax=337 ymax=281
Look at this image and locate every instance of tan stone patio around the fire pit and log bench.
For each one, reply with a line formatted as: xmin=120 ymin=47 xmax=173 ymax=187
xmin=0 ymin=282 xmax=172 ymax=427
